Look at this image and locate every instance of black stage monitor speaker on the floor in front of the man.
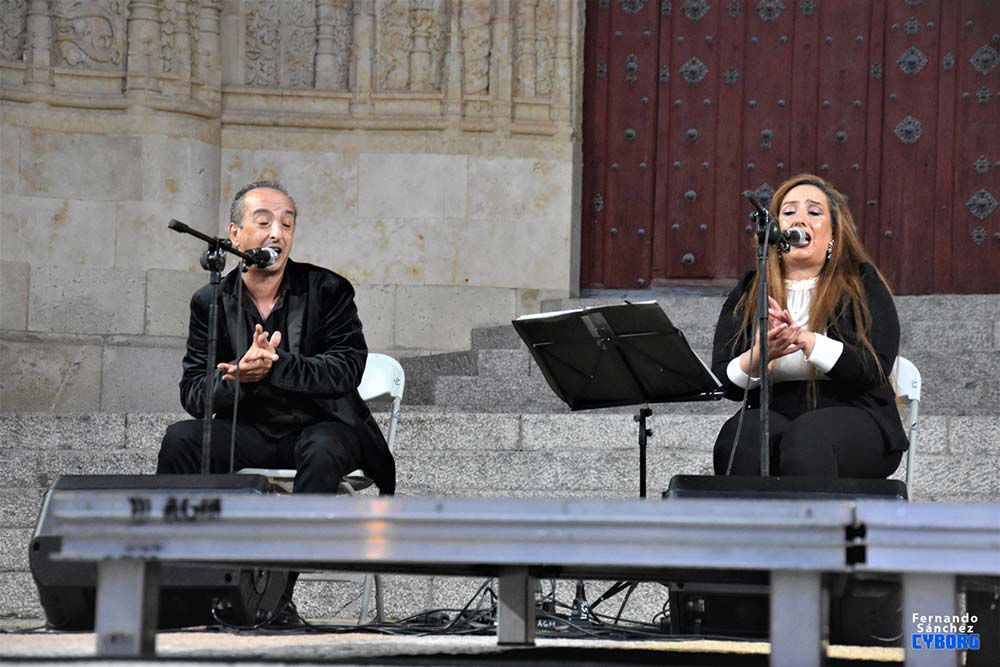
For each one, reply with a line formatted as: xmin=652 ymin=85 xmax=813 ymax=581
xmin=28 ymin=475 xmax=288 ymax=630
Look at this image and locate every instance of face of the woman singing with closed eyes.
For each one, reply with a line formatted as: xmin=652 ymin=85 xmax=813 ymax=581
xmin=778 ymin=183 xmax=833 ymax=273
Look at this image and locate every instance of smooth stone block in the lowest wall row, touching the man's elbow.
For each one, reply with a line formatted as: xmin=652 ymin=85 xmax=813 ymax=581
xmin=101 ymin=345 xmax=184 ymax=412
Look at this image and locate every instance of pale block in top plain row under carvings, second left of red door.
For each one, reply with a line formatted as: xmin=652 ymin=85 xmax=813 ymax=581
xmin=358 ymin=153 xmax=468 ymax=219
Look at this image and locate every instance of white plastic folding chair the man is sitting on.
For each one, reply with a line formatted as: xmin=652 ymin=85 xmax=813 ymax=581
xmin=239 ymin=352 xmax=406 ymax=623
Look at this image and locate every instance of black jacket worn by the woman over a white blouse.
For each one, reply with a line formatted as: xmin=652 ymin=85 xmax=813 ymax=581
xmin=712 ymin=264 xmax=909 ymax=451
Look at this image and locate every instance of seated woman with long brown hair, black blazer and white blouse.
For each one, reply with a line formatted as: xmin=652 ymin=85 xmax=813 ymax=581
xmin=712 ymin=174 xmax=908 ymax=478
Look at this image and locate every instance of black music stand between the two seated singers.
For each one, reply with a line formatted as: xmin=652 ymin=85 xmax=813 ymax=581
xmin=513 ymin=301 xmax=723 ymax=498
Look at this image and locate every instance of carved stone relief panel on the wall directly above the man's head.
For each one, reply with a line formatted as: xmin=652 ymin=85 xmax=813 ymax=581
xmin=244 ymin=0 xmax=316 ymax=88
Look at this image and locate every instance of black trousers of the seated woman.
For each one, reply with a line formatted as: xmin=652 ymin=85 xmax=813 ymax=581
xmin=713 ymin=407 xmax=903 ymax=479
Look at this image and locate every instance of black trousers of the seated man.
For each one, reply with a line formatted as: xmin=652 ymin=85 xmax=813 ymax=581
xmin=156 ymin=418 xmax=362 ymax=493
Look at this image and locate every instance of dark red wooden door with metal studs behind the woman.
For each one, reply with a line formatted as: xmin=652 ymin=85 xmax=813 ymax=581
xmin=581 ymin=0 xmax=1000 ymax=293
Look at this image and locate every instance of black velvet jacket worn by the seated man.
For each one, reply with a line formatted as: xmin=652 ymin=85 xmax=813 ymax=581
xmin=180 ymin=260 xmax=396 ymax=493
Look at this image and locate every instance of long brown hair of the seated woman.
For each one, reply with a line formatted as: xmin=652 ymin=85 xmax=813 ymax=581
xmin=733 ymin=174 xmax=889 ymax=396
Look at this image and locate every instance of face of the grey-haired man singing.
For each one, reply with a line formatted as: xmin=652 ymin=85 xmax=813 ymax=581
xmin=229 ymin=188 xmax=295 ymax=273
